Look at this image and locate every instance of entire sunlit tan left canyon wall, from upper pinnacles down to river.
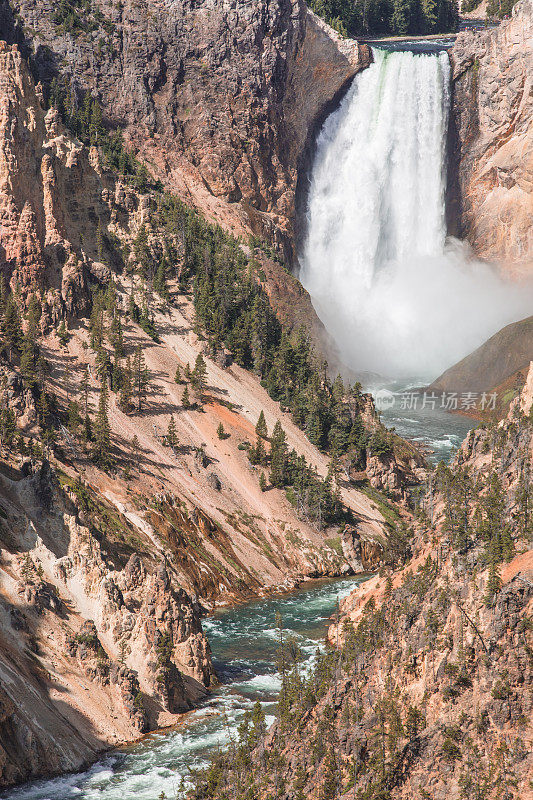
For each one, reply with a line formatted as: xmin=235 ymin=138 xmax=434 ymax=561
xmin=0 ymin=37 xmax=385 ymax=787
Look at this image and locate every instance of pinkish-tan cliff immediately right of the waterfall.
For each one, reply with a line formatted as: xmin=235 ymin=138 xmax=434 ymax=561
xmin=449 ymin=0 xmax=533 ymax=269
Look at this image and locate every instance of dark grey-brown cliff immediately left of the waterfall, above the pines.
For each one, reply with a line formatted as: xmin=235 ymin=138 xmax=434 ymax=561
xmin=4 ymin=0 xmax=370 ymax=256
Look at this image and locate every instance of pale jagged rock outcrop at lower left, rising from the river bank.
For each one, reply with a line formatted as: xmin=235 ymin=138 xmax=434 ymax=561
xmin=0 ymin=462 xmax=214 ymax=785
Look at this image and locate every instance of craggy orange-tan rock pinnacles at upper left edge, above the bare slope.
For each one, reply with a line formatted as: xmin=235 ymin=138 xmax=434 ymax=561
xmin=0 ymin=41 xmax=118 ymax=316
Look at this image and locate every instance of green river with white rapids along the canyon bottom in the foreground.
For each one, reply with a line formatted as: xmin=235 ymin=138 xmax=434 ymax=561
xmin=2 ymin=577 xmax=364 ymax=800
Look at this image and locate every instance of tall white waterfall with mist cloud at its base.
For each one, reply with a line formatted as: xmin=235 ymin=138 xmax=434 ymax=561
xmin=300 ymin=49 xmax=532 ymax=378
